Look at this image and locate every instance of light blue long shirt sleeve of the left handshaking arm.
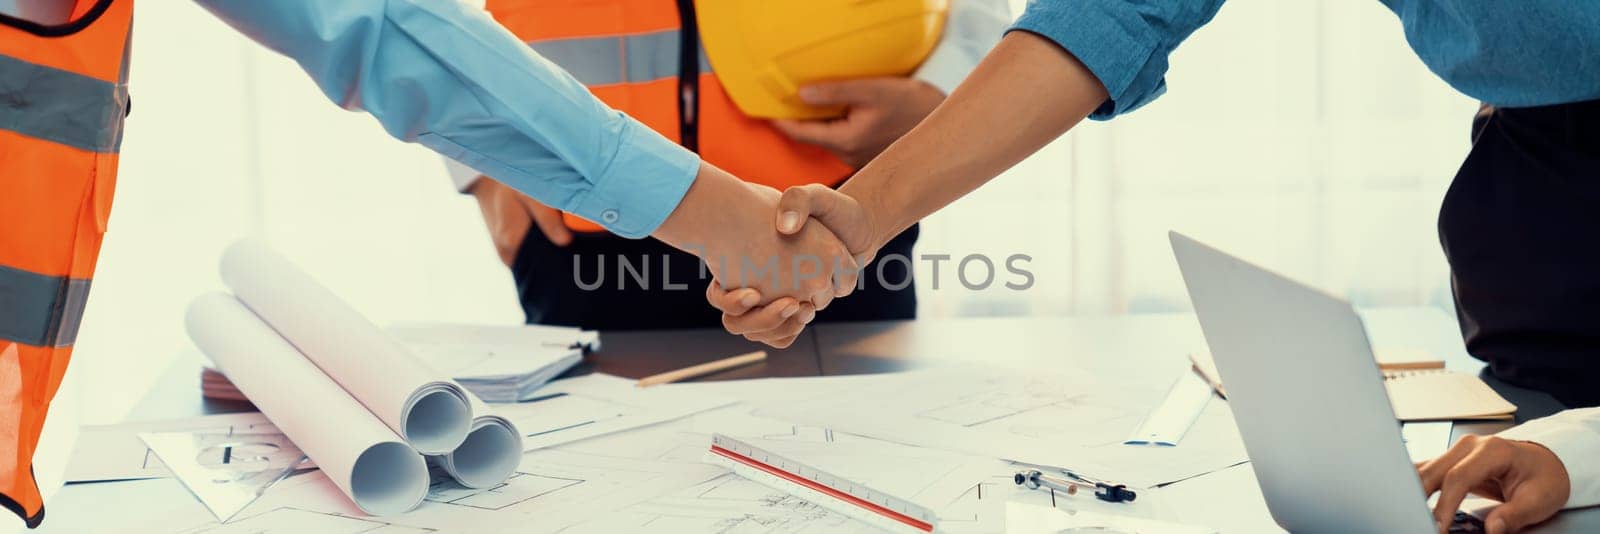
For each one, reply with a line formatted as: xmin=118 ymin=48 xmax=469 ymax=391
xmin=198 ymin=0 xmax=699 ymax=238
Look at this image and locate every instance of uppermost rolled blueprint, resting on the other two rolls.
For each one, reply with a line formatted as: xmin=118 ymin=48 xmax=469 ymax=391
xmin=222 ymin=238 xmax=472 ymax=454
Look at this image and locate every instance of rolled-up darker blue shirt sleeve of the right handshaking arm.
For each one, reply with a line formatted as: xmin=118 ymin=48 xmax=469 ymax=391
xmin=1011 ymin=0 xmax=1222 ymax=120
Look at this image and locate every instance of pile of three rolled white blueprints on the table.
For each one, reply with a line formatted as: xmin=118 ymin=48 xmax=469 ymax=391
xmin=184 ymin=240 xmax=522 ymax=515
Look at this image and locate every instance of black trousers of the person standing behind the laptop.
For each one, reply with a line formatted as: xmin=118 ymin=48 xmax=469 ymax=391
xmin=1438 ymin=101 xmax=1600 ymax=408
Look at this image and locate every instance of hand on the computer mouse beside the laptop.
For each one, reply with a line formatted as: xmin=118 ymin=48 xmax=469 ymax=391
xmin=1416 ymin=435 xmax=1573 ymax=534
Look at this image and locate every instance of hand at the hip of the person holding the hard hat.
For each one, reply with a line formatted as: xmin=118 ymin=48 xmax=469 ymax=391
xmin=472 ymin=176 xmax=573 ymax=267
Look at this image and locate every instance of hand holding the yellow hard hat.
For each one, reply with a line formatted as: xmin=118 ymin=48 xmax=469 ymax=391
xmin=773 ymin=78 xmax=944 ymax=169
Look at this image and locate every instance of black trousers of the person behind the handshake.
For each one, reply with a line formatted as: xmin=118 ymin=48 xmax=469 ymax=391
xmin=512 ymin=220 xmax=918 ymax=331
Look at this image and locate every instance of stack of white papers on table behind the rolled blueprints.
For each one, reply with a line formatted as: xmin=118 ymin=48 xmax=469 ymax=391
xmin=200 ymin=323 xmax=600 ymax=403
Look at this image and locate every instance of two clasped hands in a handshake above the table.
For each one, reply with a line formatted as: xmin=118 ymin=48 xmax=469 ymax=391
xmin=654 ymin=163 xmax=901 ymax=349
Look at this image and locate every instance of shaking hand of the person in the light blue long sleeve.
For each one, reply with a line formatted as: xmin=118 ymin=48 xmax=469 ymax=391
xmin=654 ymin=163 xmax=859 ymax=309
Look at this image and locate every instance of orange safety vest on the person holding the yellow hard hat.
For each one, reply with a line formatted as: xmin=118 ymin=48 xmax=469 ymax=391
xmin=486 ymin=0 xmax=854 ymax=232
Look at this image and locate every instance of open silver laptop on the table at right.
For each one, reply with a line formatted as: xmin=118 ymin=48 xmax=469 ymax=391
xmin=1170 ymin=232 xmax=1482 ymax=532
